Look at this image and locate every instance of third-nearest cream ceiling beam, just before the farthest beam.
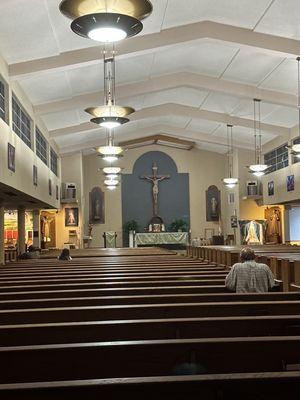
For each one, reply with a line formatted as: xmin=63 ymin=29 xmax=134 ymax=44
xmin=49 ymin=103 xmax=290 ymax=138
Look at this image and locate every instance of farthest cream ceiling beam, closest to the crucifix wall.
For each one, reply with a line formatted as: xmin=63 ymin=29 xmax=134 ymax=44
xmin=60 ymin=125 xmax=249 ymax=155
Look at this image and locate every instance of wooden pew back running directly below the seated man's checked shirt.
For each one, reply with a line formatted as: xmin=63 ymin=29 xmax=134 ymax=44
xmin=0 ymin=291 xmax=300 ymax=310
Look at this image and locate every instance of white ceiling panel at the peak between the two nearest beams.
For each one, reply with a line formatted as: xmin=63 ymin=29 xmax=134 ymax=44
xmin=151 ymin=40 xmax=238 ymax=77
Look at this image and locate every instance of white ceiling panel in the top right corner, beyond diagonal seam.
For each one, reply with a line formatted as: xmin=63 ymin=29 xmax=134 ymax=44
xmin=255 ymin=0 xmax=300 ymax=40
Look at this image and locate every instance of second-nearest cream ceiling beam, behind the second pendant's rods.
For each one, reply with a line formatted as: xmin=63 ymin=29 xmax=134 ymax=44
xmin=34 ymin=72 xmax=298 ymax=115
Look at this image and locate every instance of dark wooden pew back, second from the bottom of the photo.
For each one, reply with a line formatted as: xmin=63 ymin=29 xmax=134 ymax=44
xmin=0 ymin=336 xmax=300 ymax=384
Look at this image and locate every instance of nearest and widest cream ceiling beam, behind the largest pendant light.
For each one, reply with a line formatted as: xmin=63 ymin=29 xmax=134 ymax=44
xmin=9 ymin=21 xmax=300 ymax=78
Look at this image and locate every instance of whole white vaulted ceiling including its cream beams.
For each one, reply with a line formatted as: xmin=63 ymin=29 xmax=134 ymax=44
xmin=0 ymin=0 xmax=300 ymax=153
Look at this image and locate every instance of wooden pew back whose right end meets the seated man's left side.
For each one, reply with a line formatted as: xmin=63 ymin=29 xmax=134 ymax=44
xmin=0 ymin=285 xmax=228 ymax=300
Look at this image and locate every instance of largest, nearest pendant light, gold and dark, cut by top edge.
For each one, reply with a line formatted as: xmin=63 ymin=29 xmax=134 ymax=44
xmin=59 ymin=0 xmax=152 ymax=43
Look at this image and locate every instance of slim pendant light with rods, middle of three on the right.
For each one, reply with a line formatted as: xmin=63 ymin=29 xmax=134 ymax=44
xmin=249 ymin=99 xmax=268 ymax=177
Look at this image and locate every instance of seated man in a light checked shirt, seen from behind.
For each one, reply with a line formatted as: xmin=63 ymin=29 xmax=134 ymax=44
xmin=225 ymin=247 xmax=275 ymax=293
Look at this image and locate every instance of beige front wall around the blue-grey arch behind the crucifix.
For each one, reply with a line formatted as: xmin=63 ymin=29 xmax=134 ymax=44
xmin=79 ymin=146 xmax=227 ymax=246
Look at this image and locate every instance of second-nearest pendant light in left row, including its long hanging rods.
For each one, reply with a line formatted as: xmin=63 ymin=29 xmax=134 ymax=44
xmin=85 ymin=48 xmax=135 ymax=129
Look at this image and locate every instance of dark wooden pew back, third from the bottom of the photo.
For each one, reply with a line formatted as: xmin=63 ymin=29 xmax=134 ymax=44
xmin=0 ymin=315 xmax=300 ymax=346
